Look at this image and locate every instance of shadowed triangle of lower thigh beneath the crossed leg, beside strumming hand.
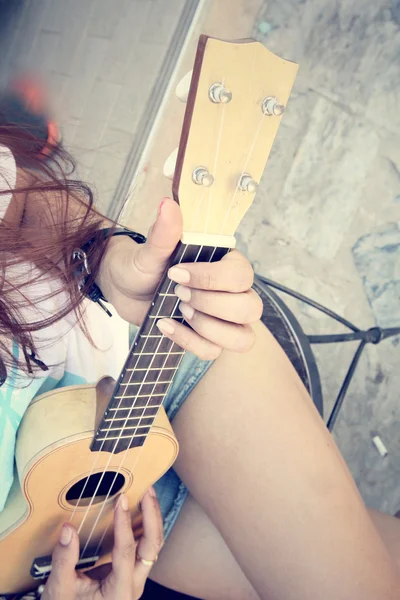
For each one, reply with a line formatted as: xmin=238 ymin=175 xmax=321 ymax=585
xmin=151 ymin=495 xmax=259 ymax=600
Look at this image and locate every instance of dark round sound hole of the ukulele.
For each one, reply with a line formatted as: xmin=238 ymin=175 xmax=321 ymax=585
xmin=65 ymin=471 xmax=125 ymax=506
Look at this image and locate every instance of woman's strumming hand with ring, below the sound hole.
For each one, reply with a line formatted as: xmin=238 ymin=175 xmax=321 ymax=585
xmin=42 ymin=488 xmax=163 ymax=600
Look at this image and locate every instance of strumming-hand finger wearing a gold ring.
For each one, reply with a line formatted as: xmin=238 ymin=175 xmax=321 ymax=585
xmin=135 ymin=488 xmax=164 ymax=583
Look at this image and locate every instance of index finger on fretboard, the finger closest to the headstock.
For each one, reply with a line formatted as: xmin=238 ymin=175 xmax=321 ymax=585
xmin=168 ymin=250 xmax=254 ymax=292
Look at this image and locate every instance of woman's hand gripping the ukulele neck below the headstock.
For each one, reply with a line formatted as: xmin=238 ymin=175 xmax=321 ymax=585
xmin=97 ymin=198 xmax=262 ymax=360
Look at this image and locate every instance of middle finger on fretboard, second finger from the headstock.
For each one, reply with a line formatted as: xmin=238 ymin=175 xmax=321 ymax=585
xmin=174 ymin=285 xmax=263 ymax=325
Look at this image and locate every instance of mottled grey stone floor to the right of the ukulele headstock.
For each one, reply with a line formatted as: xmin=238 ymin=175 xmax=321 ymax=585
xmin=244 ymin=0 xmax=400 ymax=512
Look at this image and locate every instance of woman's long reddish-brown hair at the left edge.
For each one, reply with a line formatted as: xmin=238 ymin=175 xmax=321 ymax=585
xmin=0 ymin=124 xmax=109 ymax=378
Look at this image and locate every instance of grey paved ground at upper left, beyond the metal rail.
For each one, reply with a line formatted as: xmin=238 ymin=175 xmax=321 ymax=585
xmin=0 ymin=0 xmax=186 ymax=211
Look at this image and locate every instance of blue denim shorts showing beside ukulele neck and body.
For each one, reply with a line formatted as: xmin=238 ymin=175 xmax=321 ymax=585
xmin=129 ymin=325 xmax=213 ymax=539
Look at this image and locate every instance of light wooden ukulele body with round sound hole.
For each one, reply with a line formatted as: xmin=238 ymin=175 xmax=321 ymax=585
xmin=0 ymin=378 xmax=178 ymax=595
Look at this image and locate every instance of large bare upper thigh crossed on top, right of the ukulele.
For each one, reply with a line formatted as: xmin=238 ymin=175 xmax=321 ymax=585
xmin=152 ymin=324 xmax=400 ymax=600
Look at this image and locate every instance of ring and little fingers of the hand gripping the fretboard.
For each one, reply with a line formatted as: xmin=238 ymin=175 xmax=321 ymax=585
xmin=157 ymin=303 xmax=255 ymax=360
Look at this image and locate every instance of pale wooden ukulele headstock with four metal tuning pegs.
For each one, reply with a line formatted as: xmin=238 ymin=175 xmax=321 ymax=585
xmin=168 ymin=35 xmax=298 ymax=246
